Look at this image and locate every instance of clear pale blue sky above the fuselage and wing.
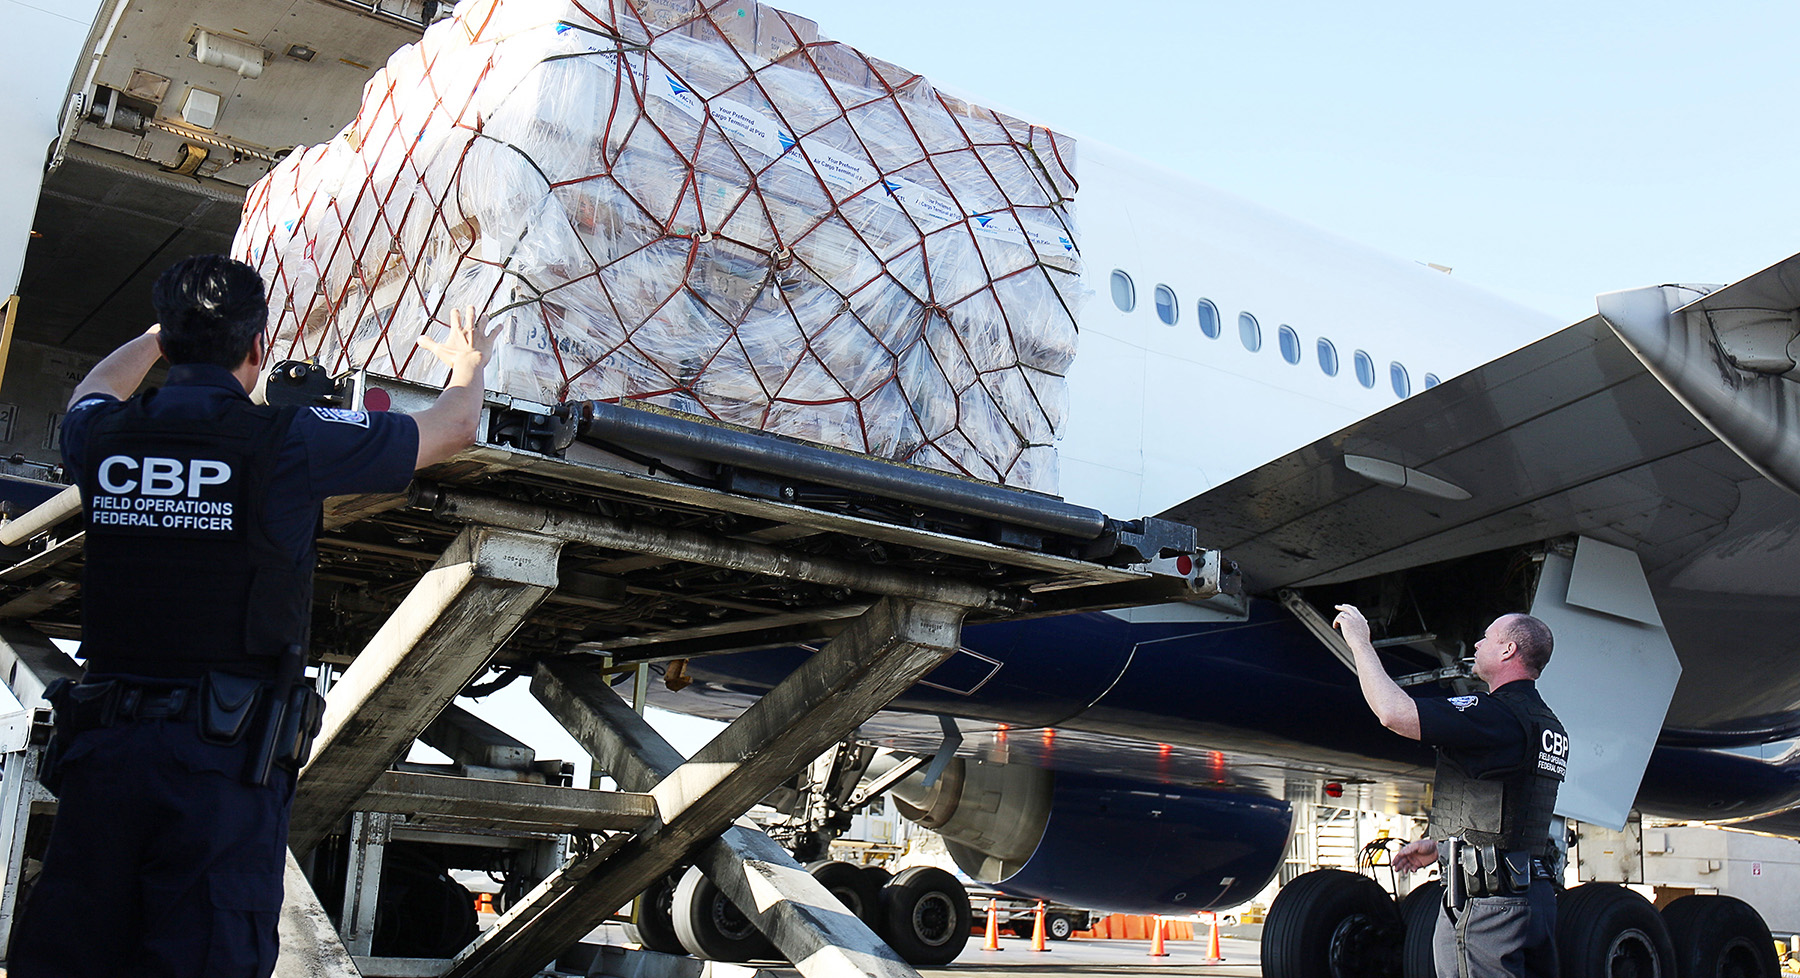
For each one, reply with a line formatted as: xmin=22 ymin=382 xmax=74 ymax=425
xmin=776 ymin=0 xmax=1800 ymax=329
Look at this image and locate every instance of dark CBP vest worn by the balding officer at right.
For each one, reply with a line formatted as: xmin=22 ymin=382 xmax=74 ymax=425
xmin=1431 ymin=681 xmax=1570 ymax=856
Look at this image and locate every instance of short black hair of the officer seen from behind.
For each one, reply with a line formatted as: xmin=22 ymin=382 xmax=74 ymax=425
xmin=149 ymin=254 xmax=268 ymax=369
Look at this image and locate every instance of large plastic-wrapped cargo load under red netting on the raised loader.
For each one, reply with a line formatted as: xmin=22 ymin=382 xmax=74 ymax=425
xmin=234 ymin=0 xmax=1084 ymax=492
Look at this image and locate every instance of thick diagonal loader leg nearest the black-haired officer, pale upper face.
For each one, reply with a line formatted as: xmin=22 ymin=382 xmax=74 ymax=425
xmin=288 ymin=528 xmax=562 ymax=854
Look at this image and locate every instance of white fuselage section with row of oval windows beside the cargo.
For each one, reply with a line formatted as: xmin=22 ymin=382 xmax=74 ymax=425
xmin=1058 ymin=140 xmax=1566 ymax=517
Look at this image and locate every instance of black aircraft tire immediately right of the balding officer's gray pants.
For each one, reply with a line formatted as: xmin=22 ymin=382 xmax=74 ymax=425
xmin=1557 ymin=883 xmax=1676 ymax=978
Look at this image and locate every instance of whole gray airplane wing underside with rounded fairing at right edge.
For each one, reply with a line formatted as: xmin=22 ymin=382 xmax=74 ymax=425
xmin=1163 ymin=256 xmax=1800 ymax=747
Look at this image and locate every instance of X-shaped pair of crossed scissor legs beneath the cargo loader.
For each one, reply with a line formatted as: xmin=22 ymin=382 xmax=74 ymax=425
xmin=446 ymin=598 xmax=967 ymax=978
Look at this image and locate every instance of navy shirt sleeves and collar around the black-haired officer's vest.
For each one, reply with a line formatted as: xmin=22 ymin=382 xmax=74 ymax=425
xmin=63 ymin=364 xmax=419 ymax=560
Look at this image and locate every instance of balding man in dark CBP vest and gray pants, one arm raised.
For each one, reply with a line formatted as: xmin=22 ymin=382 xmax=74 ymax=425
xmin=1332 ymin=605 xmax=1570 ymax=978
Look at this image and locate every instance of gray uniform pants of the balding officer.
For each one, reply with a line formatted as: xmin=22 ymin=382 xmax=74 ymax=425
xmin=1431 ymin=879 xmax=1557 ymax=978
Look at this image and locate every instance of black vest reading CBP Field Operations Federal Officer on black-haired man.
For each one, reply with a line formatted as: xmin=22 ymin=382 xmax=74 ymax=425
xmin=79 ymin=391 xmax=313 ymax=677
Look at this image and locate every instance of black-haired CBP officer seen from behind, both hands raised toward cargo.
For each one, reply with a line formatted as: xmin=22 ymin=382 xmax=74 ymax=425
xmin=9 ymin=256 xmax=491 ymax=978
